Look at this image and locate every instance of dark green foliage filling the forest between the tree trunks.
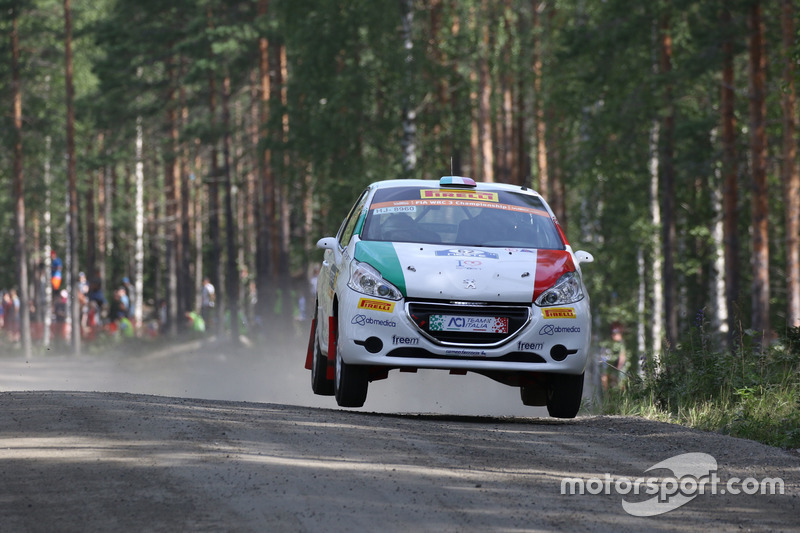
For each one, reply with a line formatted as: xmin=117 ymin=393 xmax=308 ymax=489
xmin=0 ymin=0 xmax=800 ymax=343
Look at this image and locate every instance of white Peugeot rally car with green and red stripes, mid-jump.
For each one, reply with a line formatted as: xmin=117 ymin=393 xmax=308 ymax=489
xmin=306 ymin=176 xmax=593 ymax=418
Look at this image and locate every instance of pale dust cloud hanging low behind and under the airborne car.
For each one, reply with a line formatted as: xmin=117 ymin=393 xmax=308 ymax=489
xmin=0 ymin=334 xmax=547 ymax=417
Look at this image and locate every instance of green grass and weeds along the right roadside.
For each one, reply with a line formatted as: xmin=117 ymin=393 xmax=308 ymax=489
xmin=596 ymin=328 xmax=800 ymax=448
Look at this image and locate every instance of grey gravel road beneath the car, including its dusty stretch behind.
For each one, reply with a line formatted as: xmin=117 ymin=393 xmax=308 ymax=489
xmin=0 ymin=334 xmax=800 ymax=532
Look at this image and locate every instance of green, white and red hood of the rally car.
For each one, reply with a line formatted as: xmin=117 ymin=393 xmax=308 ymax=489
xmin=355 ymin=241 xmax=575 ymax=303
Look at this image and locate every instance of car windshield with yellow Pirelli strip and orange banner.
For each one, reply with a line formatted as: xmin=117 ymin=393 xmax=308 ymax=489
xmin=361 ymin=187 xmax=564 ymax=250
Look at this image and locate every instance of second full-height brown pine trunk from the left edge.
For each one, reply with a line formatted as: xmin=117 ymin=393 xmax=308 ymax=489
xmin=64 ymin=0 xmax=81 ymax=355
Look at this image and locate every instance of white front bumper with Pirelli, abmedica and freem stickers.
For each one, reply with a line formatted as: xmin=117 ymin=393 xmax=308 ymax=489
xmin=339 ymin=290 xmax=591 ymax=374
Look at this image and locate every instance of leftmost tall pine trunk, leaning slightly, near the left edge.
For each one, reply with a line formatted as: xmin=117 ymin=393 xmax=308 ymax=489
xmin=11 ymin=11 xmax=31 ymax=359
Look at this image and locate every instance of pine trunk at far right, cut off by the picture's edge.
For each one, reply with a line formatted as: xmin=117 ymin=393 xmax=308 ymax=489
xmin=781 ymin=0 xmax=800 ymax=328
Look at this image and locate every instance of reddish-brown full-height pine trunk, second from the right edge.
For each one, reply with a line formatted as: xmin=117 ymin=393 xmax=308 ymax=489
xmin=748 ymin=2 xmax=770 ymax=340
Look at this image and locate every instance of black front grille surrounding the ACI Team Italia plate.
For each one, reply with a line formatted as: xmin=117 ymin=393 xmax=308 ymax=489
xmin=406 ymin=302 xmax=531 ymax=347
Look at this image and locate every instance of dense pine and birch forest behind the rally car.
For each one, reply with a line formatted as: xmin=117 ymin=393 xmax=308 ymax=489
xmin=0 ymin=0 xmax=800 ymax=362
